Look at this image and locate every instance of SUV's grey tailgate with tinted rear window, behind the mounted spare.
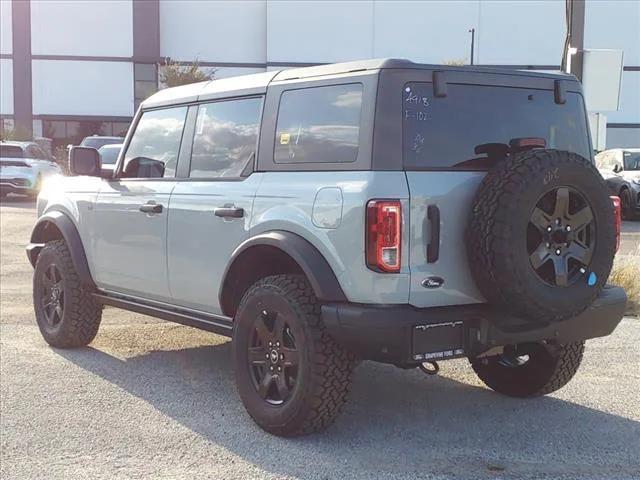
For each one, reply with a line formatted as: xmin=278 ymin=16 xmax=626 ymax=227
xmin=398 ymin=75 xmax=591 ymax=307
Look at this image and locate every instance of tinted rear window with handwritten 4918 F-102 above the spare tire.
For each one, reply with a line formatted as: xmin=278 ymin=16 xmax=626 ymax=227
xmin=402 ymin=83 xmax=591 ymax=170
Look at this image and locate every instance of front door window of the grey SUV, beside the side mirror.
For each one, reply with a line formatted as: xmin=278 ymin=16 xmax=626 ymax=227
xmin=123 ymin=107 xmax=187 ymax=178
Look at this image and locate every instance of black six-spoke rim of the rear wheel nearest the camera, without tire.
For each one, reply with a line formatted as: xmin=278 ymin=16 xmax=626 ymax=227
xmin=247 ymin=310 xmax=299 ymax=405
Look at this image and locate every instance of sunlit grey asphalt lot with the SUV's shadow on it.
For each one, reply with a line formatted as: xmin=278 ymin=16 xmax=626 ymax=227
xmin=0 ymin=197 xmax=640 ymax=480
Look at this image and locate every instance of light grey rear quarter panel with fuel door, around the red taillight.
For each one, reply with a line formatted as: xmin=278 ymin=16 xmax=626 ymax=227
xmin=250 ymin=171 xmax=410 ymax=303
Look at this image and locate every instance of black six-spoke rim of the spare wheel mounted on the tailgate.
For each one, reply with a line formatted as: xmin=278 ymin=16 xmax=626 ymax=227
xmin=527 ymin=186 xmax=596 ymax=287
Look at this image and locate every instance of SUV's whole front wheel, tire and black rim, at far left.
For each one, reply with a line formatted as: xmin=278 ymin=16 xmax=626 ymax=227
xmin=33 ymin=240 xmax=102 ymax=348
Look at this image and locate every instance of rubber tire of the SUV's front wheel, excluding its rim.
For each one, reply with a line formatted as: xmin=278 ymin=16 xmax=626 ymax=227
xmin=33 ymin=240 xmax=102 ymax=348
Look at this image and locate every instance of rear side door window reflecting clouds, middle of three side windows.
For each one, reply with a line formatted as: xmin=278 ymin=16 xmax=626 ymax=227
xmin=189 ymin=97 xmax=262 ymax=178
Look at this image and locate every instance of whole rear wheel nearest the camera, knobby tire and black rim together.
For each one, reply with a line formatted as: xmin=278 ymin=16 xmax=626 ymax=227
xmin=233 ymin=275 xmax=355 ymax=436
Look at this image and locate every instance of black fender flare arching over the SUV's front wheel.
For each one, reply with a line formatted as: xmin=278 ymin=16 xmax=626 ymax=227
xmin=27 ymin=211 xmax=96 ymax=289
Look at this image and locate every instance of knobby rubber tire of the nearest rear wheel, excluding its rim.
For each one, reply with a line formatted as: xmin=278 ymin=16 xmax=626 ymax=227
xmin=233 ymin=275 xmax=356 ymax=437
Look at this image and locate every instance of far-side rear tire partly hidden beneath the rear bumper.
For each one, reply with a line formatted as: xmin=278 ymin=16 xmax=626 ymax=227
xmin=471 ymin=342 xmax=584 ymax=397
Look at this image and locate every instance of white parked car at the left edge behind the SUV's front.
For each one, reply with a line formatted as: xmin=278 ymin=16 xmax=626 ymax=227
xmin=0 ymin=141 xmax=62 ymax=197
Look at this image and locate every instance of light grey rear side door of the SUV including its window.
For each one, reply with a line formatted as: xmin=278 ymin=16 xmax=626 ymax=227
xmin=167 ymin=96 xmax=263 ymax=314
